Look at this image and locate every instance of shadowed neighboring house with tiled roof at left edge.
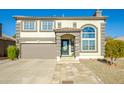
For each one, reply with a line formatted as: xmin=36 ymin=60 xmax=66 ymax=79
xmin=0 ymin=24 xmax=16 ymax=57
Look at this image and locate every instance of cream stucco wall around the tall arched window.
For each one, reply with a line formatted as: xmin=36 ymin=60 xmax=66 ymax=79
xmin=56 ymin=20 xmax=104 ymax=58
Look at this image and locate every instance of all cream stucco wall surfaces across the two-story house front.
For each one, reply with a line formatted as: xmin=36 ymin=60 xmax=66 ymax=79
xmin=18 ymin=20 xmax=104 ymax=58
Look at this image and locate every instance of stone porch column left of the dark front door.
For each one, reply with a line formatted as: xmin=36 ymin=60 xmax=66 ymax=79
xmin=56 ymin=35 xmax=61 ymax=61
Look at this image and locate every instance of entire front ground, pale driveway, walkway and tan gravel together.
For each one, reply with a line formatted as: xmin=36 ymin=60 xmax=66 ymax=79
xmin=0 ymin=59 xmax=124 ymax=84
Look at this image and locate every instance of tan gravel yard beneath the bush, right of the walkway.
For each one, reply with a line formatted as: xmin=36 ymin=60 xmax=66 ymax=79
xmin=80 ymin=59 xmax=124 ymax=84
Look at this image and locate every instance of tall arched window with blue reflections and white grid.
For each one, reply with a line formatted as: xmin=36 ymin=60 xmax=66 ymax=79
xmin=81 ymin=26 xmax=96 ymax=51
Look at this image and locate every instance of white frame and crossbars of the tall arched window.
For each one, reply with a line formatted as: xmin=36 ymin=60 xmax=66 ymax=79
xmin=81 ymin=25 xmax=98 ymax=52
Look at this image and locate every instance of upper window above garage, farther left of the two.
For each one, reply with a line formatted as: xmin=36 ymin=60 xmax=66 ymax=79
xmin=23 ymin=20 xmax=36 ymax=31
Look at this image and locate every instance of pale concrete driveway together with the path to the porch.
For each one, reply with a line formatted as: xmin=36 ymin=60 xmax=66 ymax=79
xmin=0 ymin=59 xmax=103 ymax=84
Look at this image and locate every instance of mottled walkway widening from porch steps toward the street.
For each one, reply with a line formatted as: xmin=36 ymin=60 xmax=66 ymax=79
xmin=52 ymin=60 xmax=103 ymax=84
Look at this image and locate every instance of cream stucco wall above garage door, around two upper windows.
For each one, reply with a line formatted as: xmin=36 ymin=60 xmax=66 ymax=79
xmin=17 ymin=20 xmax=55 ymax=43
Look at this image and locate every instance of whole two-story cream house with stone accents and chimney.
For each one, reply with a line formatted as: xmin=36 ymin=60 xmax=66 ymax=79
xmin=14 ymin=10 xmax=107 ymax=60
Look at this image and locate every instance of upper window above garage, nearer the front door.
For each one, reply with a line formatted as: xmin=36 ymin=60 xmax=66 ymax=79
xmin=41 ymin=21 xmax=54 ymax=31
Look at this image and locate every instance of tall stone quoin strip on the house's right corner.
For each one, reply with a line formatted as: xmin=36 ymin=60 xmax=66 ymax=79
xmin=101 ymin=23 xmax=105 ymax=56
